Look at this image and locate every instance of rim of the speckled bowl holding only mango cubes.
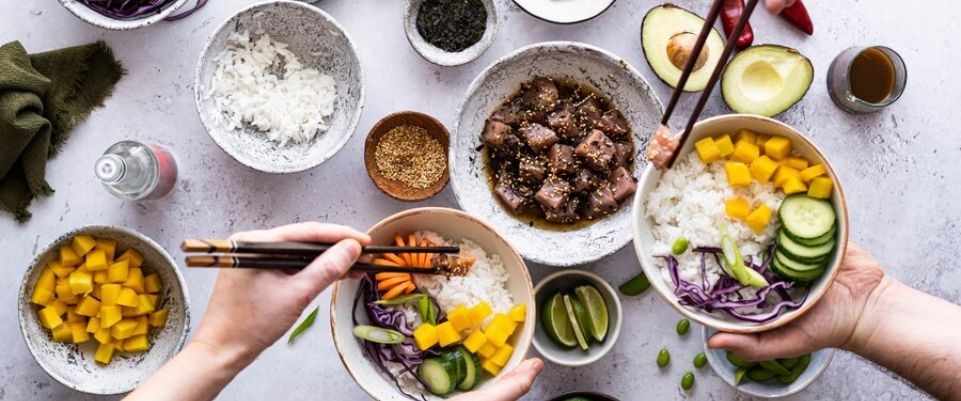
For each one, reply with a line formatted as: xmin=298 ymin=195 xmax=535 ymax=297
xmin=17 ymin=225 xmax=190 ymax=395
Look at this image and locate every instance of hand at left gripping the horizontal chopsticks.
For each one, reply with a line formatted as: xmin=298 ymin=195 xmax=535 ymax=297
xmin=192 ymin=222 xmax=370 ymax=366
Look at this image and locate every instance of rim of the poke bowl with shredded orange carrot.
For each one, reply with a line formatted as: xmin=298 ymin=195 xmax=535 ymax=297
xmin=330 ymin=207 xmax=537 ymax=399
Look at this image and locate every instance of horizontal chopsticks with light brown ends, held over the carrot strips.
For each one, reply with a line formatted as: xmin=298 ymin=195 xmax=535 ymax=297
xmin=180 ymin=239 xmax=460 ymax=274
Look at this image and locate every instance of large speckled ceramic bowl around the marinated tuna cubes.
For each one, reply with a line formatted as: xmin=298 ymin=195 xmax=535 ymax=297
xmin=448 ymin=42 xmax=663 ymax=266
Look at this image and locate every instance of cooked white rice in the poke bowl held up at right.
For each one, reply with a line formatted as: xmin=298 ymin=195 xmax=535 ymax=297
xmin=645 ymin=152 xmax=785 ymax=283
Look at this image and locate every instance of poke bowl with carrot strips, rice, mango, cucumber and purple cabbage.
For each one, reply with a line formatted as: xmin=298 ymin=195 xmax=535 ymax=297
xmin=330 ymin=208 xmax=536 ymax=400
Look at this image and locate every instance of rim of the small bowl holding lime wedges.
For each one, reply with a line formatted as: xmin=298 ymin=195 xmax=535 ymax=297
xmin=532 ymin=269 xmax=624 ymax=368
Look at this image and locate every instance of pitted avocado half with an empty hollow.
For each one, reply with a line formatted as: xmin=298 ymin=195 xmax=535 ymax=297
xmin=721 ymin=45 xmax=814 ymax=117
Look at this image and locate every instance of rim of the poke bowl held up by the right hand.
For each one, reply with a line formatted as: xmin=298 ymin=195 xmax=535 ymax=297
xmin=631 ymin=114 xmax=850 ymax=333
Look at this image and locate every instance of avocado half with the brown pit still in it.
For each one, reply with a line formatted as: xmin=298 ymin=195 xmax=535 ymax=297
xmin=641 ymin=3 xmax=724 ymax=92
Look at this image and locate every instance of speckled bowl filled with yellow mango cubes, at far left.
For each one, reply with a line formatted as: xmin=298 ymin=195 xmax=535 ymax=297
xmin=19 ymin=226 xmax=190 ymax=395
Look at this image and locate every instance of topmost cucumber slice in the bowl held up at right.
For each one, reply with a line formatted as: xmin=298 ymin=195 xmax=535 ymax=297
xmin=778 ymin=195 xmax=837 ymax=238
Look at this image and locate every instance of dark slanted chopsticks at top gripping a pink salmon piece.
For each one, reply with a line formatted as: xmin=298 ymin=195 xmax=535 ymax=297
xmin=661 ymin=0 xmax=758 ymax=169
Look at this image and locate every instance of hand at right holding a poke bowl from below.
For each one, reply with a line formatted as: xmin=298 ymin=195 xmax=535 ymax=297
xmin=708 ymin=242 xmax=886 ymax=361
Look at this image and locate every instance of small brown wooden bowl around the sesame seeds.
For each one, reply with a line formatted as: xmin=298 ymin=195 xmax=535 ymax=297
xmin=364 ymin=111 xmax=450 ymax=202
